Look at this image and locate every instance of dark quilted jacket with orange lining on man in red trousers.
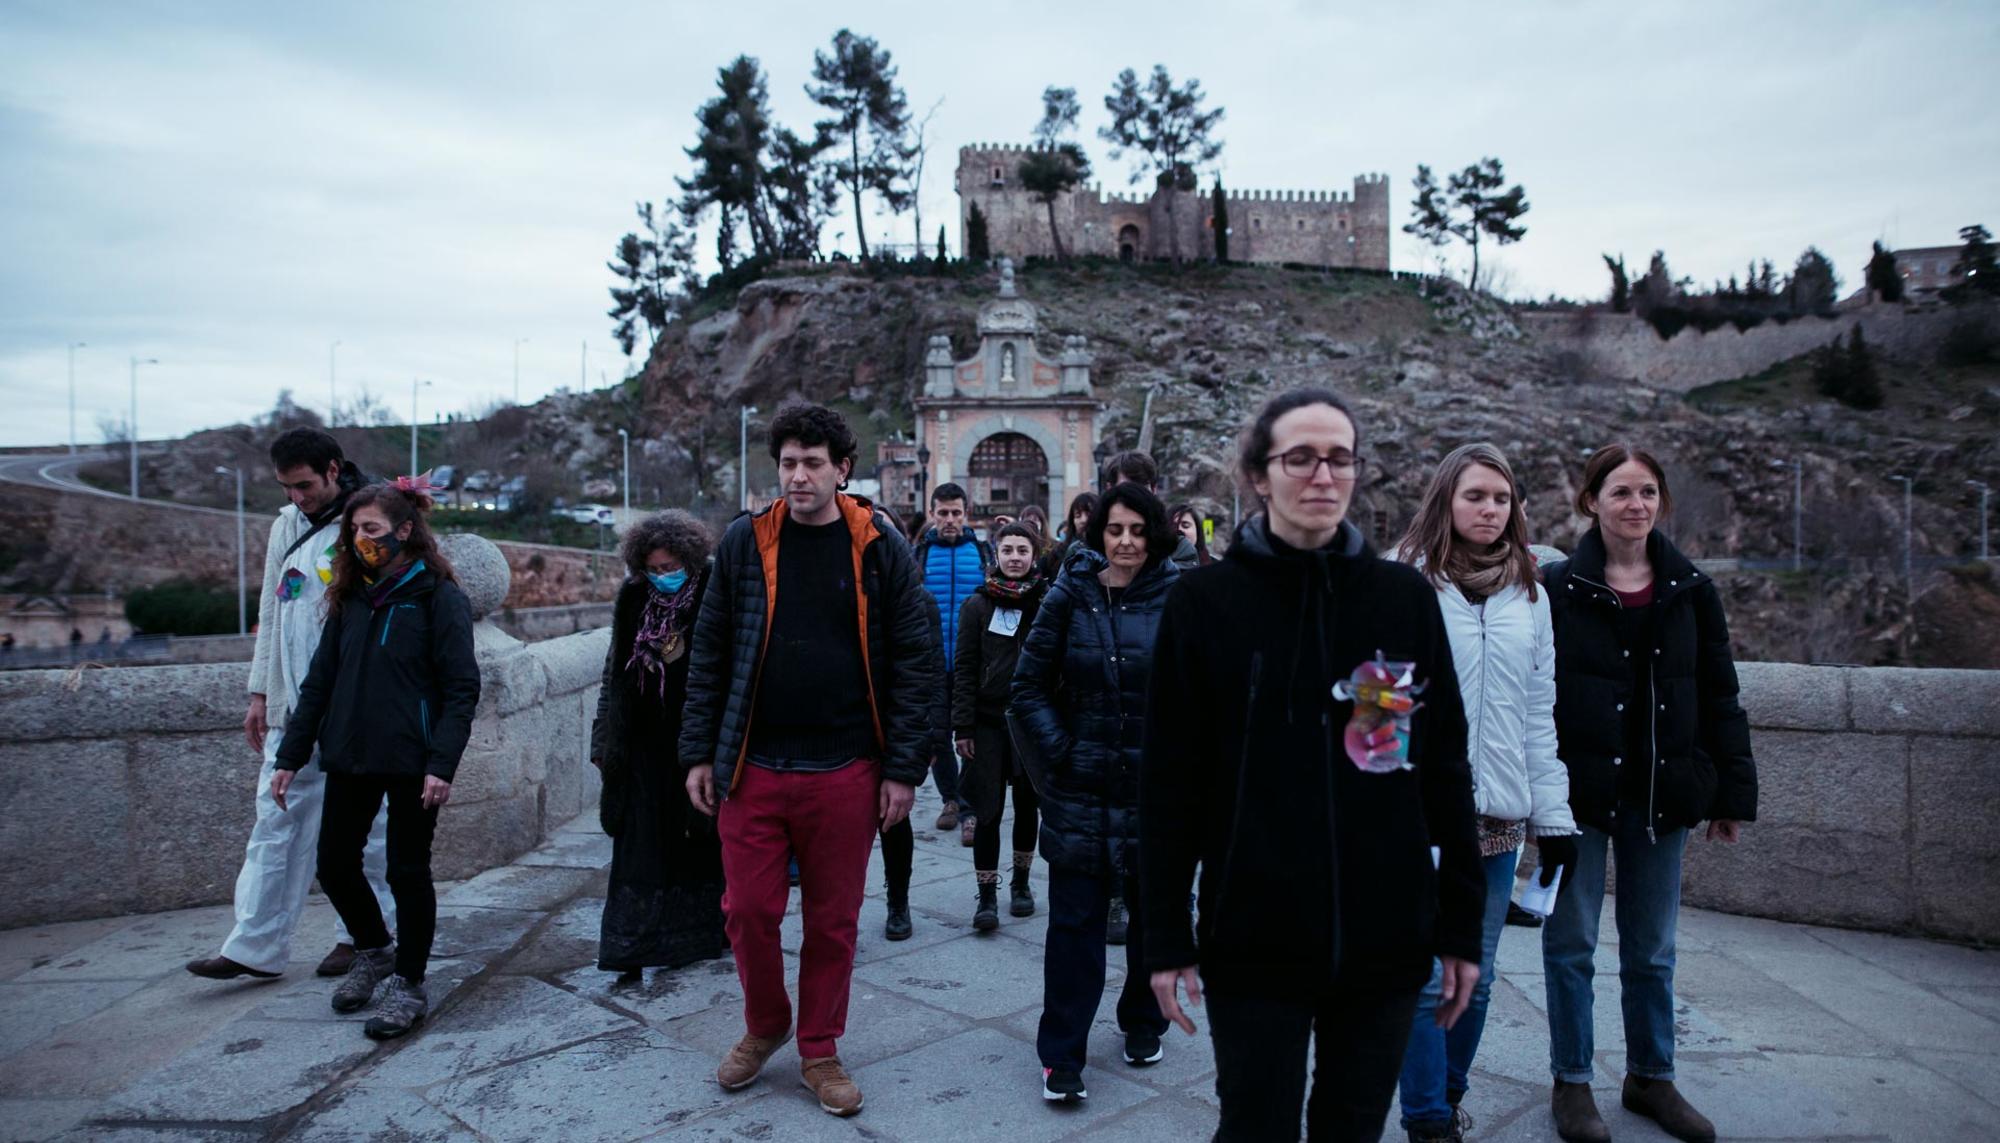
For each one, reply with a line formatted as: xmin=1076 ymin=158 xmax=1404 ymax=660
xmin=680 ymin=494 xmax=938 ymax=797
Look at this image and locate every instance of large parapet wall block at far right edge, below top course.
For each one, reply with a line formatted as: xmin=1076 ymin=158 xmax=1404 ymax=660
xmin=1910 ymin=737 xmax=2000 ymax=941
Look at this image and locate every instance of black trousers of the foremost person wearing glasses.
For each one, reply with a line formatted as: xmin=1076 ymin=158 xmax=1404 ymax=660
xmin=1202 ymin=981 xmax=1418 ymax=1143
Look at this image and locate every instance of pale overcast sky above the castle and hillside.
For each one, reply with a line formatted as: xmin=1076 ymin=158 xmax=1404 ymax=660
xmin=0 ymin=0 xmax=2000 ymax=444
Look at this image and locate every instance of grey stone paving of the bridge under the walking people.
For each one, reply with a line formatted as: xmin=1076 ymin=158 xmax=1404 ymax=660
xmin=0 ymin=789 xmax=2000 ymax=1143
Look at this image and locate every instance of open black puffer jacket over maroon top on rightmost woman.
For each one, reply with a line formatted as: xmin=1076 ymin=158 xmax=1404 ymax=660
xmin=1542 ymin=528 xmax=1756 ymax=831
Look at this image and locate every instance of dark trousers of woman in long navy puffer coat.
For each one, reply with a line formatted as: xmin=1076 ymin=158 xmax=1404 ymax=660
xmin=1034 ymin=867 xmax=1168 ymax=1071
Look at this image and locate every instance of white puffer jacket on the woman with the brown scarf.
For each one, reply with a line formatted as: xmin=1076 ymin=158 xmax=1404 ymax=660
xmin=1438 ymin=585 xmax=1576 ymax=837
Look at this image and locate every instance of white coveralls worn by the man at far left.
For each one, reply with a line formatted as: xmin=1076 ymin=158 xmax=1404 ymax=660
xmin=222 ymin=506 xmax=396 ymax=973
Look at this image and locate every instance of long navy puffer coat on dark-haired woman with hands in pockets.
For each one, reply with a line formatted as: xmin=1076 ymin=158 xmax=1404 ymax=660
xmin=1008 ymin=548 xmax=1180 ymax=875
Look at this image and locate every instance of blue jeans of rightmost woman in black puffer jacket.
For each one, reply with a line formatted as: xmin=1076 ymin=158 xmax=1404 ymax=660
xmin=1542 ymin=813 xmax=1688 ymax=1083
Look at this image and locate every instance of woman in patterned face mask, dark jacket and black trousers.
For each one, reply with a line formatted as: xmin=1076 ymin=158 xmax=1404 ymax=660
xmin=270 ymin=478 xmax=480 ymax=1039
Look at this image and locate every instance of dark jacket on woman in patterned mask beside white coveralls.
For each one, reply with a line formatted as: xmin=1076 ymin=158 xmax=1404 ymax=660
xmin=278 ymin=562 xmax=480 ymax=781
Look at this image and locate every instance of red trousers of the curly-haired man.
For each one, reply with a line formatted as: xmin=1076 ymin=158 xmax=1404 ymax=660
xmin=716 ymin=759 xmax=882 ymax=1059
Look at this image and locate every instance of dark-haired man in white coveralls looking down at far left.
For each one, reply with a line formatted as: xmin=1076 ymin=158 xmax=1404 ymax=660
xmin=188 ymin=428 xmax=396 ymax=981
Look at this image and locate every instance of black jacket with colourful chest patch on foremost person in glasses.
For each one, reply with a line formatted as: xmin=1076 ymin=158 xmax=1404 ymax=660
xmin=1140 ymin=516 xmax=1486 ymax=995
